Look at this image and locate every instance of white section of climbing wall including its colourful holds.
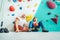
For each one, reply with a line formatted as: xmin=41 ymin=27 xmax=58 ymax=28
xmin=2 ymin=0 xmax=41 ymax=31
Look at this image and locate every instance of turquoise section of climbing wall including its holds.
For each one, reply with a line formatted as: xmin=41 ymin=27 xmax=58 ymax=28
xmin=35 ymin=0 xmax=60 ymax=32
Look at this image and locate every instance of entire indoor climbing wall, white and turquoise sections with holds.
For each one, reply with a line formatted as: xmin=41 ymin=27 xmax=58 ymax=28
xmin=1 ymin=0 xmax=60 ymax=32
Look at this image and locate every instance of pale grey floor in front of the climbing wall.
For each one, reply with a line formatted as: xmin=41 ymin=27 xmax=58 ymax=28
xmin=0 ymin=32 xmax=60 ymax=40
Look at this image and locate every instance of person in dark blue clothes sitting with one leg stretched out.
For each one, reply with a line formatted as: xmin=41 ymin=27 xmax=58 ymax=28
xmin=31 ymin=17 xmax=48 ymax=32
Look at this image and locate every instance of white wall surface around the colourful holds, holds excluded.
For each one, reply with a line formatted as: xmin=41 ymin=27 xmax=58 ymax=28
xmin=2 ymin=0 xmax=41 ymax=31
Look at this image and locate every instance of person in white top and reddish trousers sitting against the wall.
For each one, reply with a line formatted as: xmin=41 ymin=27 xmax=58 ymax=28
xmin=14 ymin=14 xmax=29 ymax=32
